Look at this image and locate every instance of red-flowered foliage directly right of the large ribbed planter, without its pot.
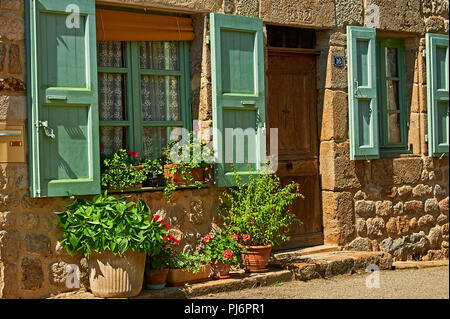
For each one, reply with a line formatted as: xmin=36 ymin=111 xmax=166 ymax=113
xmin=146 ymin=215 xmax=180 ymax=275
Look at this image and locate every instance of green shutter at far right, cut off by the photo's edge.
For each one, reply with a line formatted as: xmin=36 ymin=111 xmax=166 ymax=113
xmin=426 ymin=33 xmax=449 ymax=156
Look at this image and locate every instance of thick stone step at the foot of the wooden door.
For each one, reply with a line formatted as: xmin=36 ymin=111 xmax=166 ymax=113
xmin=272 ymin=251 xmax=393 ymax=281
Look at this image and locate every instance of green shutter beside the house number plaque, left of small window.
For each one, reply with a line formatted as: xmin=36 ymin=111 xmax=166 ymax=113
xmin=347 ymin=26 xmax=379 ymax=160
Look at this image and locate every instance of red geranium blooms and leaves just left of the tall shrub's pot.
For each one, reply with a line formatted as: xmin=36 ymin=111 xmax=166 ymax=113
xmin=203 ymin=233 xmax=241 ymax=265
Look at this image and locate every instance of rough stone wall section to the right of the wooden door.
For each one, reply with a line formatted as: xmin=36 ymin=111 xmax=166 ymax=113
xmin=317 ymin=0 xmax=449 ymax=260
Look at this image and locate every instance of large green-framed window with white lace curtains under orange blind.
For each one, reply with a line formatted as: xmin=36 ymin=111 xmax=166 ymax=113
xmin=97 ymin=41 xmax=190 ymax=158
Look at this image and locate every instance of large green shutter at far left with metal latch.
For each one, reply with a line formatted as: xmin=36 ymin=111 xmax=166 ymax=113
xmin=26 ymin=0 xmax=100 ymax=197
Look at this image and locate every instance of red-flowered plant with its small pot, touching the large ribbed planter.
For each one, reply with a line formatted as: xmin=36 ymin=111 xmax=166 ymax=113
xmin=145 ymin=215 xmax=180 ymax=290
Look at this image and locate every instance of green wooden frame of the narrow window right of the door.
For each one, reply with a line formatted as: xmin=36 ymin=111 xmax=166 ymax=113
xmin=376 ymin=37 xmax=411 ymax=155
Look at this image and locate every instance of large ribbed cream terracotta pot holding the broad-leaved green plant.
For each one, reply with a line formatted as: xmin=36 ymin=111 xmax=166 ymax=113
xmin=88 ymin=250 xmax=146 ymax=298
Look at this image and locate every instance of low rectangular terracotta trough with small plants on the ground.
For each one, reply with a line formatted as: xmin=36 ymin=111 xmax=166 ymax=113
xmin=167 ymin=251 xmax=211 ymax=287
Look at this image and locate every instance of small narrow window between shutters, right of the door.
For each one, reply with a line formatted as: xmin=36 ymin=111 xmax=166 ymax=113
xmin=377 ymin=38 xmax=408 ymax=153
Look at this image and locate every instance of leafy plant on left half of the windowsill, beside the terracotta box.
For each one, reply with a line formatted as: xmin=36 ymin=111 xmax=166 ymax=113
xmin=101 ymin=149 xmax=150 ymax=190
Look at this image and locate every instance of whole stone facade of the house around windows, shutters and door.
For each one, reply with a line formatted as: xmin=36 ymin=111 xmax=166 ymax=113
xmin=0 ymin=0 xmax=449 ymax=298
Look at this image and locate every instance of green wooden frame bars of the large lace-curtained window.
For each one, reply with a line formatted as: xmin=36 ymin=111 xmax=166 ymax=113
xmin=97 ymin=41 xmax=192 ymax=159
